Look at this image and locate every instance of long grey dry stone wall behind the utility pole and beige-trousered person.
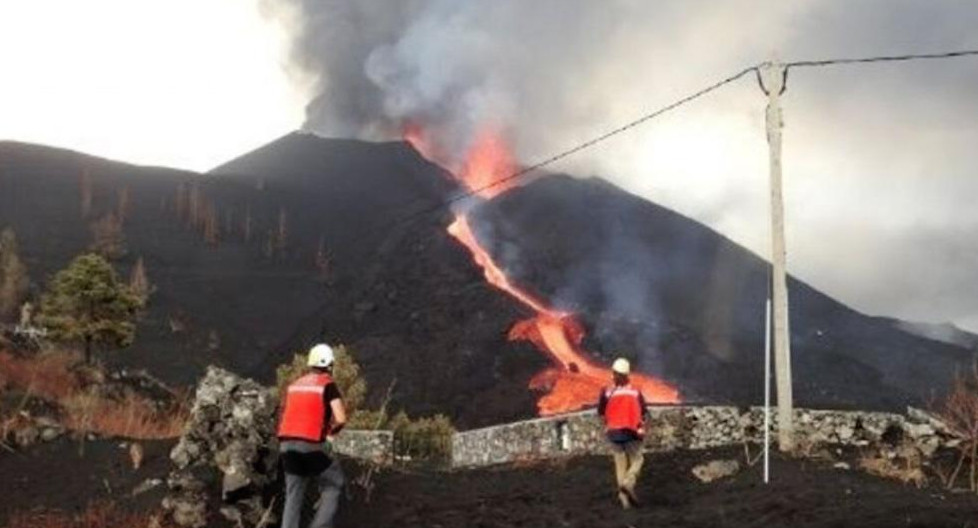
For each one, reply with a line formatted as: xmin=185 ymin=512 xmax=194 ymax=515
xmin=452 ymin=406 xmax=957 ymax=468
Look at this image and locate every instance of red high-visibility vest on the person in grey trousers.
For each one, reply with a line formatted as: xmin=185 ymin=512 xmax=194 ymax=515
xmin=278 ymin=373 xmax=333 ymax=442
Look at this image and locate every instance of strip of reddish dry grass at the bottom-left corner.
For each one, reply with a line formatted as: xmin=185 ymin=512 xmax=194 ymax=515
xmin=6 ymin=503 xmax=173 ymax=528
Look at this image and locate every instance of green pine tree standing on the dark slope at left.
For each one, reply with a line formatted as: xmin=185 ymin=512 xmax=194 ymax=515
xmin=39 ymin=254 xmax=141 ymax=363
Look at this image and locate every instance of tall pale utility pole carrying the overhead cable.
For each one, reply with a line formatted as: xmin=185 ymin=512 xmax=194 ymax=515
xmin=759 ymin=61 xmax=795 ymax=451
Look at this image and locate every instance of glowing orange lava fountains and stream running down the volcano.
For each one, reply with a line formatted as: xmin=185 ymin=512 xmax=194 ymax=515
xmin=405 ymin=126 xmax=679 ymax=415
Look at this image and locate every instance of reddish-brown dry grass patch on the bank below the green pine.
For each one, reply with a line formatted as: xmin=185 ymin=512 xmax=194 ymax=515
xmin=0 ymin=352 xmax=189 ymax=440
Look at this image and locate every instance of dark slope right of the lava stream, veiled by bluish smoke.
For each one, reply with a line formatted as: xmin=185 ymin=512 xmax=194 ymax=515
xmin=468 ymin=176 xmax=975 ymax=410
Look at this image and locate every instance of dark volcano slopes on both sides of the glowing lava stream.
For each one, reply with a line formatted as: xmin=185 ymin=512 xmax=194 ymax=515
xmin=0 ymin=133 xmax=974 ymax=428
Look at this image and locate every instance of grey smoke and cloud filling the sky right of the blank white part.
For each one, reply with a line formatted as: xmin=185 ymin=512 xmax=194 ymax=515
xmin=265 ymin=0 xmax=978 ymax=330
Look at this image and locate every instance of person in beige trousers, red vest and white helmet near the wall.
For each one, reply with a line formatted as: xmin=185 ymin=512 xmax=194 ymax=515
xmin=598 ymin=358 xmax=648 ymax=509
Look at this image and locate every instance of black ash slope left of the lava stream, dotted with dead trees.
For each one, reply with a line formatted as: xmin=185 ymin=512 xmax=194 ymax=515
xmin=0 ymin=138 xmax=543 ymax=426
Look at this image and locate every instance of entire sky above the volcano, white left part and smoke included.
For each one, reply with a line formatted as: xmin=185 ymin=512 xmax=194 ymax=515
xmin=0 ymin=0 xmax=978 ymax=331
